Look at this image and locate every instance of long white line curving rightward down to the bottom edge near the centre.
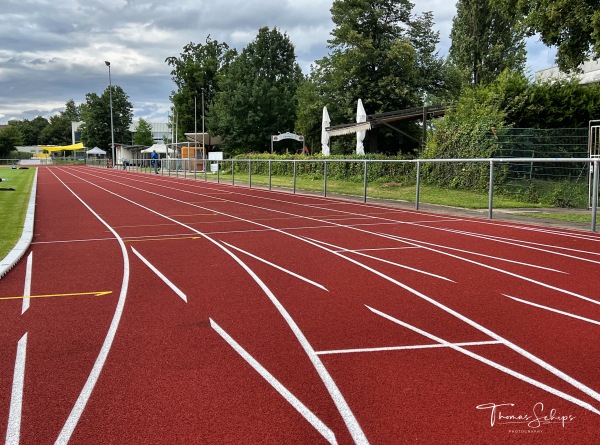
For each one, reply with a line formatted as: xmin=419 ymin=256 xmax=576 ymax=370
xmin=59 ymin=167 xmax=369 ymax=444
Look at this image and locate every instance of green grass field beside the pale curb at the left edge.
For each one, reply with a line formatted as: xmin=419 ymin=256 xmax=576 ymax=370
xmin=0 ymin=167 xmax=35 ymax=258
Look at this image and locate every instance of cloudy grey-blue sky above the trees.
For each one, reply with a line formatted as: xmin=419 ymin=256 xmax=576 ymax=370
xmin=0 ymin=0 xmax=554 ymax=124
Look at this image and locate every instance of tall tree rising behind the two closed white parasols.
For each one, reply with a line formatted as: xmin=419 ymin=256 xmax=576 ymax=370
xmin=311 ymin=0 xmax=447 ymax=152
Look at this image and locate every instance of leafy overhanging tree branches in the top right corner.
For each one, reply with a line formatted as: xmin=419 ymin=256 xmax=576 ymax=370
xmin=500 ymin=0 xmax=600 ymax=72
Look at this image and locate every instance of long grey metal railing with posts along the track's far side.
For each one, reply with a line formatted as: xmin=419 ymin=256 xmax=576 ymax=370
xmin=88 ymin=157 xmax=600 ymax=232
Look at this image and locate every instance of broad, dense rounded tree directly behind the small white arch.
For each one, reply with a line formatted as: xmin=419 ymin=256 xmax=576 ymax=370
xmin=208 ymin=27 xmax=302 ymax=154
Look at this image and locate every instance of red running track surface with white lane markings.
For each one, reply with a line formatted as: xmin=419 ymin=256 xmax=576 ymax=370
xmin=0 ymin=167 xmax=600 ymax=445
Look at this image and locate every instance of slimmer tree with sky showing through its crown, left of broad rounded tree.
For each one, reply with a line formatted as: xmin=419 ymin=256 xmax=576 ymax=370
xmin=165 ymin=36 xmax=237 ymax=137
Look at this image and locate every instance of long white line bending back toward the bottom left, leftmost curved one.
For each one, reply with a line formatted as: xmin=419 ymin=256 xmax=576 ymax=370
xmin=49 ymin=169 xmax=129 ymax=445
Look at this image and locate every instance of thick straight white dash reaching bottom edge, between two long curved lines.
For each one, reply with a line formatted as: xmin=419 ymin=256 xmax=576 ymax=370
xmin=210 ymin=318 xmax=337 ymax=444
